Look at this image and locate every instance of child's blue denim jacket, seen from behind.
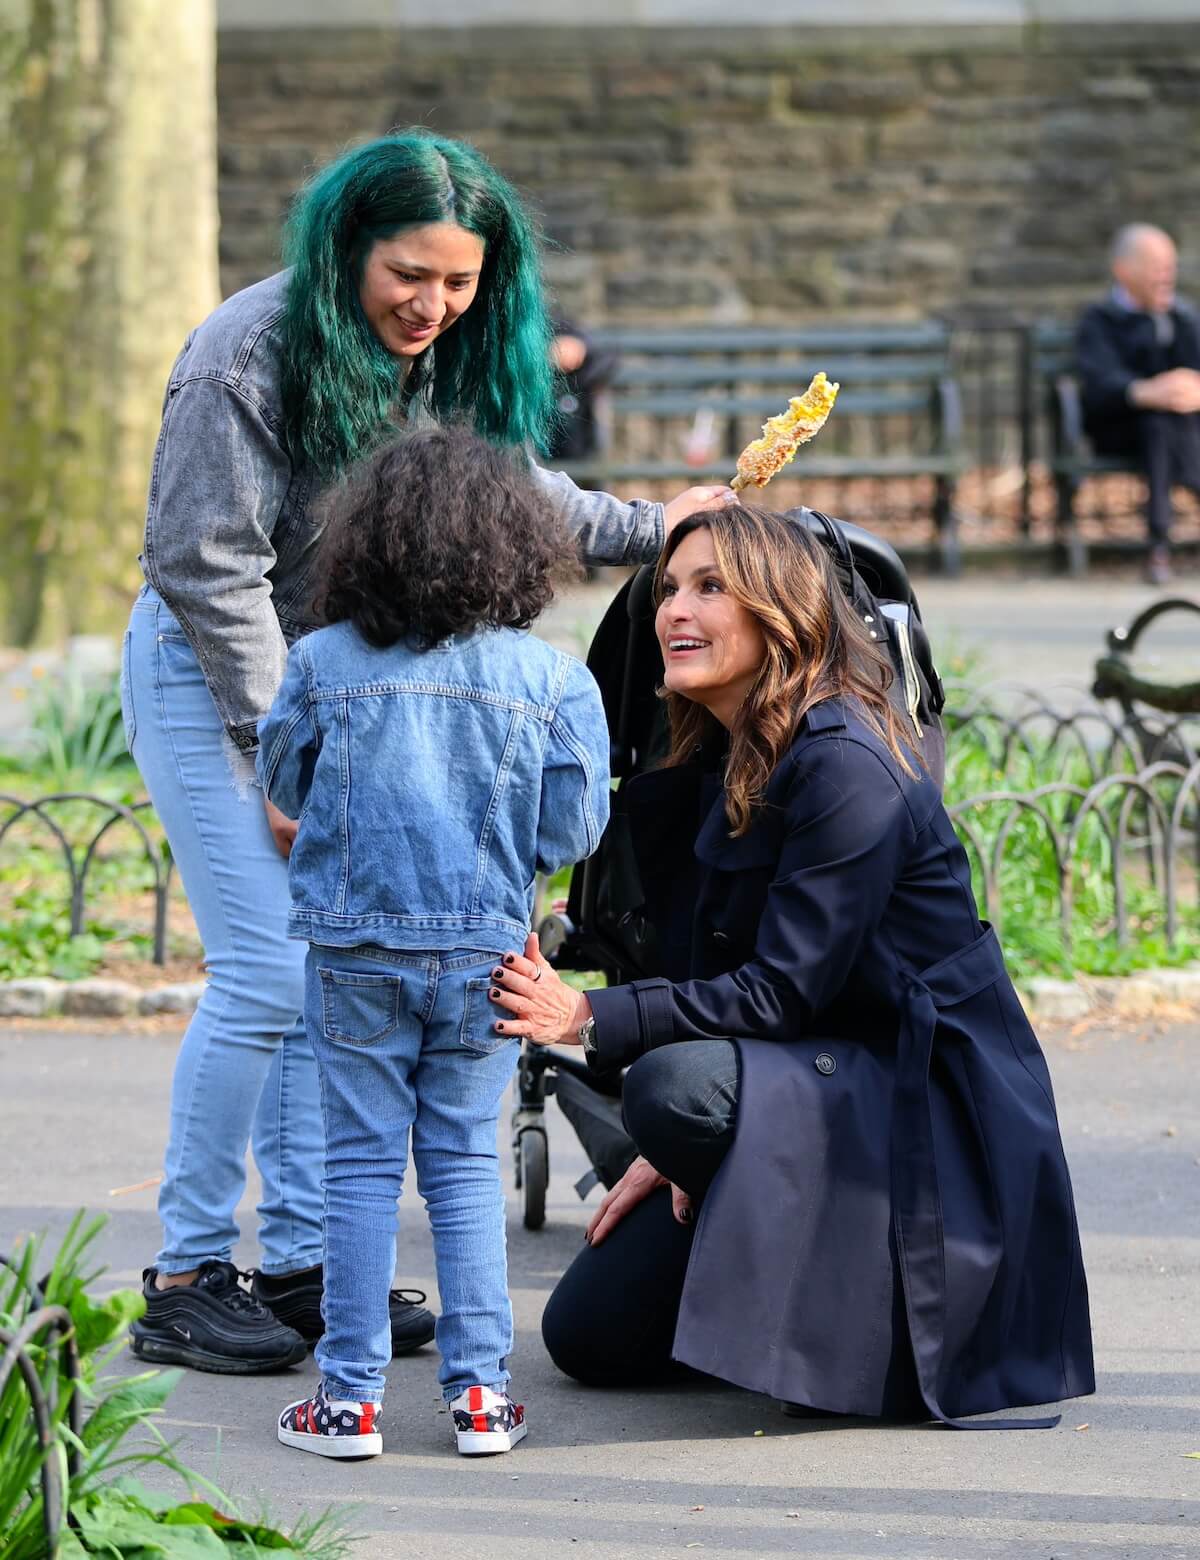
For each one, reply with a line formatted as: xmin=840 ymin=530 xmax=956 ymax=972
xmin=257 ymin=622 xmax=609 ymax=955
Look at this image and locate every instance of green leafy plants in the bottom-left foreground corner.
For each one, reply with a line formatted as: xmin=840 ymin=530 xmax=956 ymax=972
xmin=0 ymin=1214 xmax=348 ymax=1560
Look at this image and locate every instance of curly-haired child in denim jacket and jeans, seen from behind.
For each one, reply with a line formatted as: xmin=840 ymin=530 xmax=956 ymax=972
xmin=259 ymin=427 xmax=609 ymax=1457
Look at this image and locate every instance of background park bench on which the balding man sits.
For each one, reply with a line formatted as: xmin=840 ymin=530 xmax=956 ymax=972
xmin=1024 ymin=320 xmax=1141 ymax=576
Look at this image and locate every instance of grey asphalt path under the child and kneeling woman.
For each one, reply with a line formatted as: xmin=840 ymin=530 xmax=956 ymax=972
xmin=0 ymin=1023 xmax=1200 ymax=1560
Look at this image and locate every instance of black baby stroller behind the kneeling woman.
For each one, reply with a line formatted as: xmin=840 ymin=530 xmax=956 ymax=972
xmin=512 ymin=509 xmax=946 ymax=1229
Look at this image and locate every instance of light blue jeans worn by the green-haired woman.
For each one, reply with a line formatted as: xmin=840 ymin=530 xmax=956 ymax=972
xmin=122 ymin=588 xmax=321 ymax=1275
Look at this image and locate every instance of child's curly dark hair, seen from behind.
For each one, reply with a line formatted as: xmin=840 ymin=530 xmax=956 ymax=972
xmin=315 ymin=427 xmax=579 ymax=649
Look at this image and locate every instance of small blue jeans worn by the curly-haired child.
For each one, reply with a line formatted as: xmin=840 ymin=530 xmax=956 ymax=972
xmin=304 ymin=945 xmax=520 ymax=1402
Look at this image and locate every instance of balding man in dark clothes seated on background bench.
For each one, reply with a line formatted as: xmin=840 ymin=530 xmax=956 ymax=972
xmin=1077 ymin=223 xmax=1200 ymax=585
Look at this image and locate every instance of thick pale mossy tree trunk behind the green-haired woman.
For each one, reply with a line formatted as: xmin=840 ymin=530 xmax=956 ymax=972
xmin=0 ymin=0 xmax=218 ymax=644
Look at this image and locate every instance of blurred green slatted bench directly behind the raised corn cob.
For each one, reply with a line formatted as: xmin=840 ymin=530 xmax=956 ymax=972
xmin=552 ymin=321 xmax=966 ymax=574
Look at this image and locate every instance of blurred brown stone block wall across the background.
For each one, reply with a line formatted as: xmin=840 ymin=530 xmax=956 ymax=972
xmin=218 ymin=23 xmax=1200 ymax=324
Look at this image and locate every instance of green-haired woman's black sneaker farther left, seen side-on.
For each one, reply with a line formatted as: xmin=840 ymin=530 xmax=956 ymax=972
xmin=130 ymin=1262 xmax=307 ymax=1376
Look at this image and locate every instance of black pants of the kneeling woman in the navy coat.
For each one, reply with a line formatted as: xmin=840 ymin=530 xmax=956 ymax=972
xmin=541 ymin=1041 xmax=738 ymax=1387
